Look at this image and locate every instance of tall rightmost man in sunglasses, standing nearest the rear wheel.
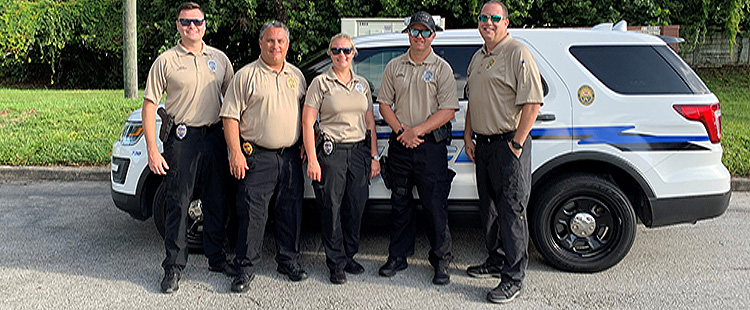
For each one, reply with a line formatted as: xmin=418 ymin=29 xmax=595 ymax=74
xmin=464 ymin=1 xmax=543 ymax=303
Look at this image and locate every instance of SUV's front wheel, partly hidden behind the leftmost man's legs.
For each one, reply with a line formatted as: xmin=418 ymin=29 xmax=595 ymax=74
xmin=152 ymin=183 xmax=203 ymax=252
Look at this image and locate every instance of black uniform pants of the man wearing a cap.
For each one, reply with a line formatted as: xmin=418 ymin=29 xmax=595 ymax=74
xmin=387 ymin=133 xmax=455 ymax=267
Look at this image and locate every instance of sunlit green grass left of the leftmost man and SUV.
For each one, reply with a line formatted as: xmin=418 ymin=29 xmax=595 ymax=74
xmin=0 ymin=88 xmax=141 ymax=166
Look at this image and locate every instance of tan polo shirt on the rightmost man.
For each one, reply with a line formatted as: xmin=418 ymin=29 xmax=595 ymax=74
xmin=466 ymin=34 xmax=544 ymax=135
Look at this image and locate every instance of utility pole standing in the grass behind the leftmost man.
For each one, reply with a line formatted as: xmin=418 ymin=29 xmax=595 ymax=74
xmin=122 ymin=0 xmax=138 ymax=99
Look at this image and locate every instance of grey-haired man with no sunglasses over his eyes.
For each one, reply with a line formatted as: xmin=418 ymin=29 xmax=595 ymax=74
xmin=221 ymin=21 xmax=307 ymax=292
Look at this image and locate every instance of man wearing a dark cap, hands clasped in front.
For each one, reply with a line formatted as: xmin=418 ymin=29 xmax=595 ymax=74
xmin=377 ymin=11 xmax=458 ymax=284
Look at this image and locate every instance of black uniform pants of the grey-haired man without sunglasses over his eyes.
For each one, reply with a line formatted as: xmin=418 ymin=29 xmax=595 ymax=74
xmin=234 ymin=145 xmax=304 ymax=274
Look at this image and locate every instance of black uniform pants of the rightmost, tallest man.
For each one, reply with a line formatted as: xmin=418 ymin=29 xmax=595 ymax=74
xmin=475 ymin=135 xmax=531 ymax=281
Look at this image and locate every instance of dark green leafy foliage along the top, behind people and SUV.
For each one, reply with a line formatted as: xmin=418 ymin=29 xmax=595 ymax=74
xmin=0 ymin=0 xmax=750 ymax=88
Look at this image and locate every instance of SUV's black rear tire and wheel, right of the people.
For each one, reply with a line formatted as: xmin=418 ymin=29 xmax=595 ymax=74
xmin=530 ymin=174 xmax=636 ymax=272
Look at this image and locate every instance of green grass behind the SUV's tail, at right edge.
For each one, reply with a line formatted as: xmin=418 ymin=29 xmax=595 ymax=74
xmin=697 ymin=67 xmax=750 ymax=176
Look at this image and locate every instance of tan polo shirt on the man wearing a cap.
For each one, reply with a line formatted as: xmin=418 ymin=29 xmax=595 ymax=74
xmin=378 ymin=50 xmax=458 ymax=127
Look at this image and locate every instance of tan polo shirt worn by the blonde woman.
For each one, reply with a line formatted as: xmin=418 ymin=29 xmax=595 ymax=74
xmin=305 ymin=68 xmax=372 ymax=143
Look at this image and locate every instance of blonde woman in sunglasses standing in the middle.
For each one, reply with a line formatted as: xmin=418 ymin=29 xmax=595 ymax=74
xmin=302 ymin=33 xmax=380 ymax=284
